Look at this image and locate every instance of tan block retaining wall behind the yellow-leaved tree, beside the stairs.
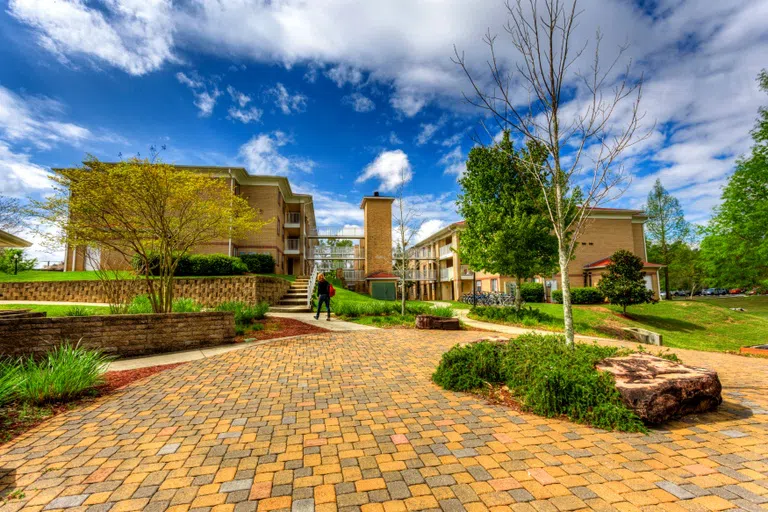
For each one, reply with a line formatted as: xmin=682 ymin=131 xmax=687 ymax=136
xmin=0 ymin=276 xmax=291 ymax=307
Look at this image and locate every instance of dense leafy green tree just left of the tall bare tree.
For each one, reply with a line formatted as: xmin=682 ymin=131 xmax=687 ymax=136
xmin=457 ymin=131 xmax=557 ymax=309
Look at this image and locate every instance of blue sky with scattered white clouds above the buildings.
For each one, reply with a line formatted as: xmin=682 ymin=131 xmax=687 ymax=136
xmin=0 ymin=0 xmax=768 ymax=259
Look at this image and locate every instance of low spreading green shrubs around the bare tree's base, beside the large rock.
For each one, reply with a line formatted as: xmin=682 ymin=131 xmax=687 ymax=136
xmin=432 ymin=334 xmax=646 ymax=432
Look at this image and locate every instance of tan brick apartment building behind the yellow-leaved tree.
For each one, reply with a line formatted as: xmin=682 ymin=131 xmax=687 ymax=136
xmin=64 ymin=165 xmax=317 ymax=275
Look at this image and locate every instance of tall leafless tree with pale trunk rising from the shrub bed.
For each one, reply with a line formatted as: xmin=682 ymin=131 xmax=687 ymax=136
xmin=454 ymin=0 xmax=650 ymax=343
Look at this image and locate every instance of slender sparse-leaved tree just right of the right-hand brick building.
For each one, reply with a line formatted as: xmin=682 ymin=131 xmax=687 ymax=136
xmin=645 ymin=179 xmax=691 ymax=300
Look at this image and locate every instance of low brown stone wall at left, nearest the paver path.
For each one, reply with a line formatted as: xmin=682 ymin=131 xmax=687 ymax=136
xmin=0 ymin=312 xmax=235 ymax=357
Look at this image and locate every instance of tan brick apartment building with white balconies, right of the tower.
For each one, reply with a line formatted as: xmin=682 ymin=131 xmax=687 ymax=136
xmin=410 ymin=208 xmax=661 ymax=300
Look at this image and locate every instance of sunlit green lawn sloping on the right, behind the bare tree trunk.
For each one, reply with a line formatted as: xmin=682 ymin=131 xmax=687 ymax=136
xmin=468 ymin=299 xmax=768 ymax=352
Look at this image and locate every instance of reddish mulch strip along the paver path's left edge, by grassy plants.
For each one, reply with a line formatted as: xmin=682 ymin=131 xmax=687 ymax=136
xmin=0 ymin=363 xmax=185 ymax=445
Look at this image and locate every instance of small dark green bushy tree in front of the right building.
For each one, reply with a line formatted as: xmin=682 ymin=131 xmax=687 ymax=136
xmin=597 ymin=249 xmax=653 ymax=315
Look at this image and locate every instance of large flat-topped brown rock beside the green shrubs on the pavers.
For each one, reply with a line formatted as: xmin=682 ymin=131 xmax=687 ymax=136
xmin=597 ymin=354 xmax=723 ymax=423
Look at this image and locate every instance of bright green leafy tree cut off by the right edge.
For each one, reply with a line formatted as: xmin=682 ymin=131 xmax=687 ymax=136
xmin=701 ymin=70 xmax=768 ymax=286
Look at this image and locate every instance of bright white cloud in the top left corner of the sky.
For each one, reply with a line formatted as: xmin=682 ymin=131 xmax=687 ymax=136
xmin=8 ymin=0 xmax=177 ymax=75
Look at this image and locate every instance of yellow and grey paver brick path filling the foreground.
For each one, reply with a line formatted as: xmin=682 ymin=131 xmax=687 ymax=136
xmin=0 ymin=330 xmax=768 ymax=512
